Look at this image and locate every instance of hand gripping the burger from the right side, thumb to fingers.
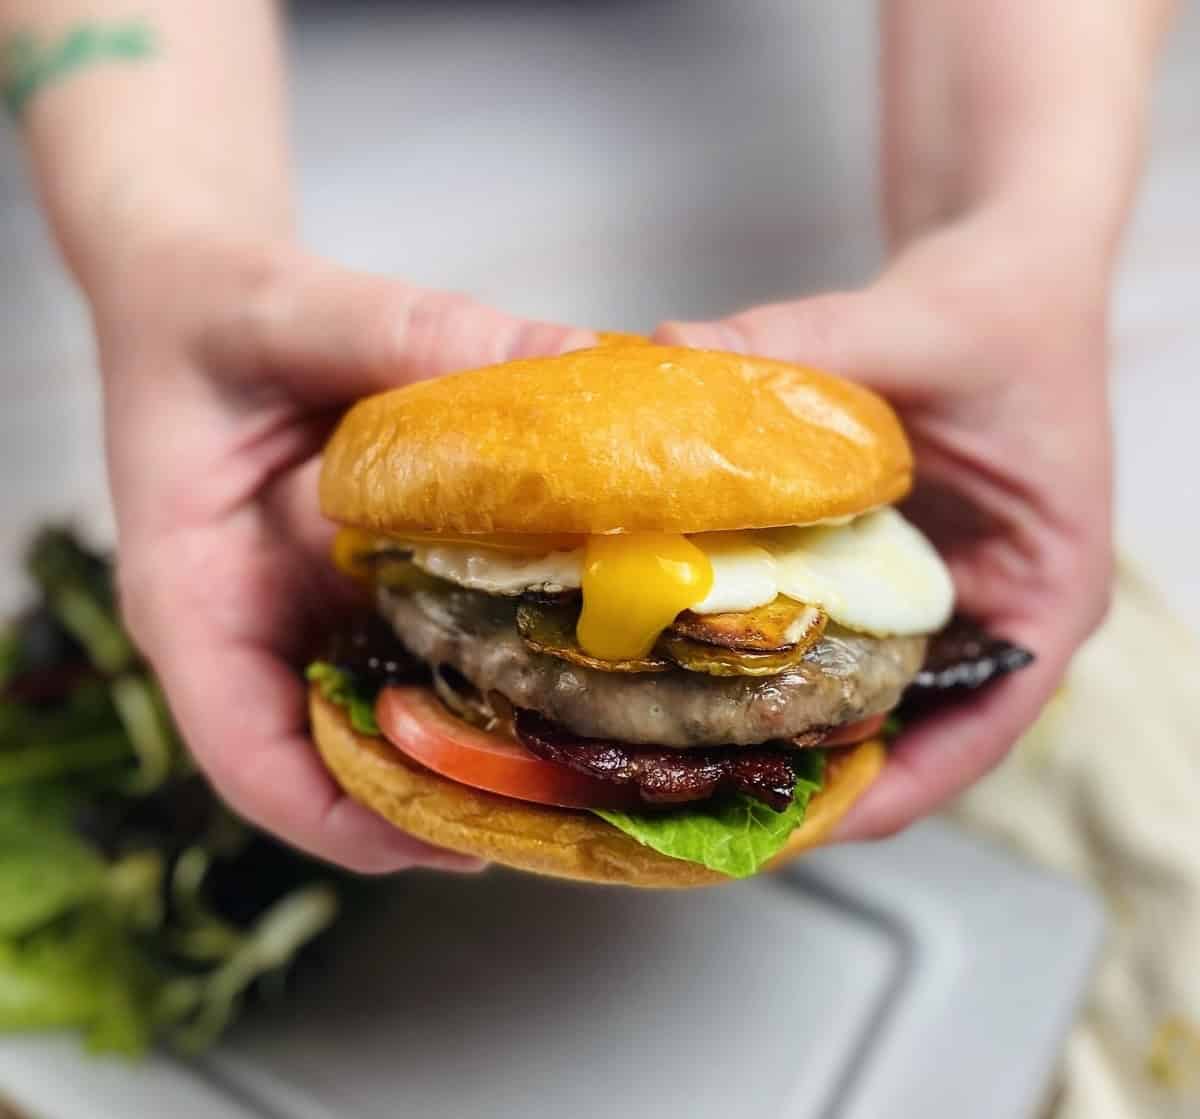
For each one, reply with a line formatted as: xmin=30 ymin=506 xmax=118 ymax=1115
xmin=656 ymin=209 xmax=1112 ymax=839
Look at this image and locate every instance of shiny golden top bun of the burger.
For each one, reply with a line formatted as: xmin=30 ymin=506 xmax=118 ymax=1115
xmin=320 ymin=341 xmax=912 ymax=534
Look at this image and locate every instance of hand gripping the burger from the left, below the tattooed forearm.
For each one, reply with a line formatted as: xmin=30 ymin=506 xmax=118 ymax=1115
xmin=92 ymin=240 xmax=592 ymax=872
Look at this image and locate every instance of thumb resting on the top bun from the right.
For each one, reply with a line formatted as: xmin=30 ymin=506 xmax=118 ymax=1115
xmin=654 ymin=286 xmax=946 ymax=402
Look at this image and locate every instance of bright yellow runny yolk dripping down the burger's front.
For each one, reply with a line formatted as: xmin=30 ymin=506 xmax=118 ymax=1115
xmin=575 ymin=532 xmax=713 ymax=660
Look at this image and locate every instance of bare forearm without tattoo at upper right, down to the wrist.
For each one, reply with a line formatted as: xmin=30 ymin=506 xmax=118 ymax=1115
xmin=882 ymin=0 xmax=1162 ymax=256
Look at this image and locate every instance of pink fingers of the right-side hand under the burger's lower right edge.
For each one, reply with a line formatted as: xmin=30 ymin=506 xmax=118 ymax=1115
xmin=832 ymin=633 xmax=1067 ymax=843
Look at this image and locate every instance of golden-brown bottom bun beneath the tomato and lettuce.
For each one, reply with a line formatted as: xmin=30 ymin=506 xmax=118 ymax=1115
xmin=310 ymin=689 xmax=884 ymax=887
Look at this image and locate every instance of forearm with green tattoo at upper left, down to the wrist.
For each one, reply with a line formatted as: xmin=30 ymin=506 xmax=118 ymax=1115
xmin=8 ymin=0 xmax=293 ymax=293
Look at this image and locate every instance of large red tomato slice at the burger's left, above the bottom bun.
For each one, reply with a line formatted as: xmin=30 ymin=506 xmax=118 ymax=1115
xmin=376 ymin=687 xmax=646 ymax=808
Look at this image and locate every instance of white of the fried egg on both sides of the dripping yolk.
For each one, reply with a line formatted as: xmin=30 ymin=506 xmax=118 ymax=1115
xmin=413 ymin=508 xmax=954 ymax=636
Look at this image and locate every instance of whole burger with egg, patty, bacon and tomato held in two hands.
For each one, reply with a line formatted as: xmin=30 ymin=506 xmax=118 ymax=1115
xmin=308 ymin=339 xmax=1028 ymax=886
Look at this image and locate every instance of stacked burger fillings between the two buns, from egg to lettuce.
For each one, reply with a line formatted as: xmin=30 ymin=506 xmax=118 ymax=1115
xmin=311 ymin=509 xmax=1036 ymax=875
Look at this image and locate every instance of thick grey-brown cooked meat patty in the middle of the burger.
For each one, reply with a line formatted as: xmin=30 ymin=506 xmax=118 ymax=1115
xmin=379 ymin=588 xmax=926 ymax=747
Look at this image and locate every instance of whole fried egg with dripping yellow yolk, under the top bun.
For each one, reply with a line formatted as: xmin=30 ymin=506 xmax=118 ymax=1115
xmin=403 ymin=508 xmax=954 ymax=659
